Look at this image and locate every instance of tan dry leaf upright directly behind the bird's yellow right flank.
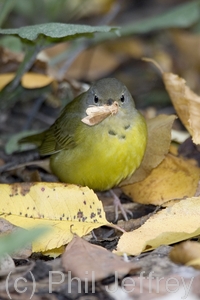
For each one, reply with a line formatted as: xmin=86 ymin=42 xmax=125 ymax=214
xmin=120 ymin=115 xmax=176 ymax=186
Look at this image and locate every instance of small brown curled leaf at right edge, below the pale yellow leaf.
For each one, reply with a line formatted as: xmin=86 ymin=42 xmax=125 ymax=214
xmin=169 ymin=241 xmax=200 ymax=269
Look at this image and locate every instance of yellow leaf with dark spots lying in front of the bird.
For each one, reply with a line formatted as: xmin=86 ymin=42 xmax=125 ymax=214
xmin=0 ymin=182 xmax=111 ymax=252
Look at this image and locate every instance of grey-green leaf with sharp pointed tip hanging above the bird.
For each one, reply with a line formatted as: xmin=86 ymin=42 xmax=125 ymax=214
xmin=0 ymin=23 xmax=117 ymax=41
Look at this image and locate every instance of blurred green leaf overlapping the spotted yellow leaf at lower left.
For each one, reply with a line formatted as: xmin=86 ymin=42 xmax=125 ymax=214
xmin=0 ymin=227 xmax=49 ymax=257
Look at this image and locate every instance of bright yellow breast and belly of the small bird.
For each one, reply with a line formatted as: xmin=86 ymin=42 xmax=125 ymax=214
xmin=51 ymin=112 xmax=147 ymax=191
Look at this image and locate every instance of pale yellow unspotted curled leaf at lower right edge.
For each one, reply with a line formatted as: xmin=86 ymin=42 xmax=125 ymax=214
xmin=114 ymin=197 xmax=200 ymax=255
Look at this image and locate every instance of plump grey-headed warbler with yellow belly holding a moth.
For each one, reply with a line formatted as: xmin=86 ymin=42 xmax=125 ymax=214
xmin=20 ymin=78 xmax=147 ymax=191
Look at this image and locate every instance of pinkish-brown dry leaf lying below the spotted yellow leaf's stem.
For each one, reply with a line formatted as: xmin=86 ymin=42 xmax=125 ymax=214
xmin=62 ymin=236 xmax=140 ymax=281
